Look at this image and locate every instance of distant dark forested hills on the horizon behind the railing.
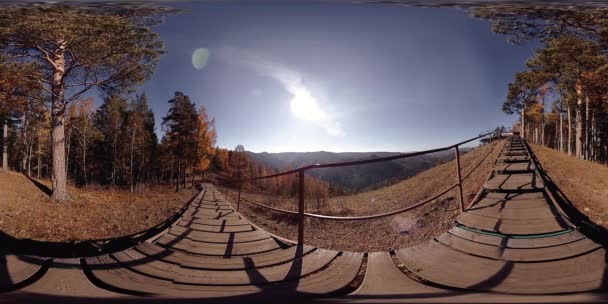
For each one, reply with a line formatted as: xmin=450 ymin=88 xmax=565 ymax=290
xmin=248 ymin=149 xmax=470 ymax=191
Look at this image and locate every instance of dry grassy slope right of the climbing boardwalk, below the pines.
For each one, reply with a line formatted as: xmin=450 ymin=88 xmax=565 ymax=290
xmin=530 ymin=144 xmax=608 ymax=227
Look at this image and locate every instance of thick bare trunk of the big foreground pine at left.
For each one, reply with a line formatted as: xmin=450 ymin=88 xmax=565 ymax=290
xmin=51 ymin=41 xmax=68 ymax=202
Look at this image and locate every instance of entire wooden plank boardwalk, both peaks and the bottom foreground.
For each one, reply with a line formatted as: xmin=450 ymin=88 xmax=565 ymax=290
xmin=0 ymin=137 xmax=608 ymax=303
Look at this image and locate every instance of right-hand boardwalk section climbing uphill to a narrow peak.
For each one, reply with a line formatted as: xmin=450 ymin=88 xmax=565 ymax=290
xmin=397 ymin=137 xmax=608 ymax=294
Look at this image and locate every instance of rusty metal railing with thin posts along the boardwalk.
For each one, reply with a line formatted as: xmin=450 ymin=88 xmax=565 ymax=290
xmin=226 ymin=131 xmax=500 ymax=244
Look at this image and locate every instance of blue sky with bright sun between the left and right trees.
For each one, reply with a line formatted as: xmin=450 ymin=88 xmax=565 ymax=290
xmin=142 ymin=2 xmax=533 ymax=152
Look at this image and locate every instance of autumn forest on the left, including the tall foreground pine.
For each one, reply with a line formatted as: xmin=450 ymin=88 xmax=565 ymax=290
xmin=0 ymin=5 xmax=252 ymax=201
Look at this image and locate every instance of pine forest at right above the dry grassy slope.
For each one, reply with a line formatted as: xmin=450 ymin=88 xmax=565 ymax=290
xmin=472 ymin=5 xmax=608 ymax=164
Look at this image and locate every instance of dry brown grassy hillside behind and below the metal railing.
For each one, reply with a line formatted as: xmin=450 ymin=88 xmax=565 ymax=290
xmin=229 ymin=141 xmax=504 ymax=252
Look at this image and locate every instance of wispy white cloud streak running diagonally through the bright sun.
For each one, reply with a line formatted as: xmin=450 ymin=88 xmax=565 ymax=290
xmin=217 ymin=47 xmax=345 ymax=136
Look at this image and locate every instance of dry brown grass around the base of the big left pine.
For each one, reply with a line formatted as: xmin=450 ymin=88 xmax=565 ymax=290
xmin=0 ymin=170 xmax=192 ymax=241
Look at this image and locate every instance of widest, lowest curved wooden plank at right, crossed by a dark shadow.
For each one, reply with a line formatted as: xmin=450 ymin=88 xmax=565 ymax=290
xmin=397 ymin=242 xmax=606 ymax=293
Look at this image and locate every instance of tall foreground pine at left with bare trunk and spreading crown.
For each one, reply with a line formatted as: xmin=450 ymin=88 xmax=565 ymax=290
xmin=0 ymin=5 xmax=162 ymax=201
